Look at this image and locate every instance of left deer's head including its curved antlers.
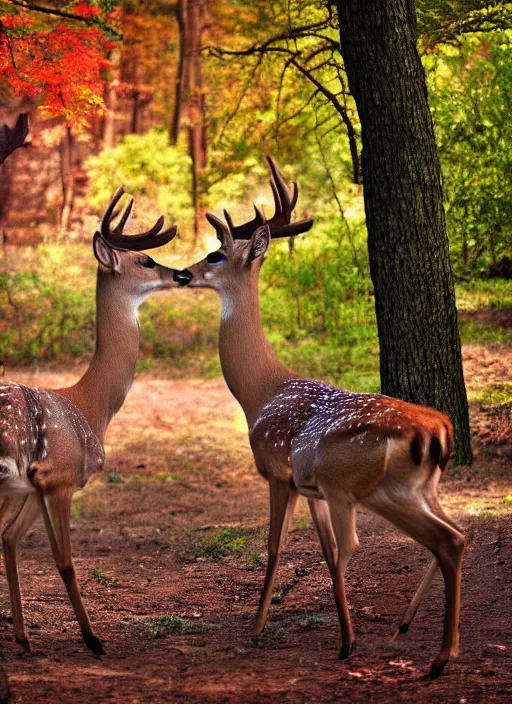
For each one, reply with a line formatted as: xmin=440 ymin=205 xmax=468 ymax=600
xmin=93 ymin=187 xmax=179 ymax=302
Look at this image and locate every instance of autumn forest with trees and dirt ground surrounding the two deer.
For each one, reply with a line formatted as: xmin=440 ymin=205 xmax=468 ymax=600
xmin=0 ymin=0 xmax=512 ymax=704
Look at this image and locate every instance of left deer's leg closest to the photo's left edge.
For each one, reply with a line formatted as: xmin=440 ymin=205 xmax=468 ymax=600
xmin=2 ymin=495 xmax=39 ymax=651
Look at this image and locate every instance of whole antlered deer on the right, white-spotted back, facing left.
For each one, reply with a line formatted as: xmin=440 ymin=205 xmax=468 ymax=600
xmin=176 ymin=157 xmax=464 ymax=679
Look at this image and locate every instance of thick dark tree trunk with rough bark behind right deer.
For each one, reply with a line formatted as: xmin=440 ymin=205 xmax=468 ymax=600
xmin=337 ymin=0 xmax=472 ymax=463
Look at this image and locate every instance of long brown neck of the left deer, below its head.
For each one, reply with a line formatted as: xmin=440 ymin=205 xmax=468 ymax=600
xmin=60 ymin=271 xmax=140 ymax=442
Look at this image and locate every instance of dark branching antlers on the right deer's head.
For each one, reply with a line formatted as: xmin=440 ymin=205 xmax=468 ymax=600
xmin=224 ymin=156 xmax=313 ymax=240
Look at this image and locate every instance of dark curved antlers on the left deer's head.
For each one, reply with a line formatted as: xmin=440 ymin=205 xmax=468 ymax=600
xmin=101 ymin=186 xmax=178 ymax=252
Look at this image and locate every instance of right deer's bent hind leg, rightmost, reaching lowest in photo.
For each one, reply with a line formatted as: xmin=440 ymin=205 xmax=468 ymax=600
xmin=365 ymin=494 xmax=464 ymax=679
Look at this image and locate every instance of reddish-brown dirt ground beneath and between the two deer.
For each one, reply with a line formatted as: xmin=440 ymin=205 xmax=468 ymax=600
xmin=0 ymin=345 xmax=512 ymax=704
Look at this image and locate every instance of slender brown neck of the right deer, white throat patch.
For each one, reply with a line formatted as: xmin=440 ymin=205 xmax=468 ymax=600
xmin=219 ymin=266 xmax=294 ymax=427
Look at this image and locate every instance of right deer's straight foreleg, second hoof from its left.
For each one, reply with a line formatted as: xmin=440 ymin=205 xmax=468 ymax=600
xmin=322 ymin=498 xmax=359 ymax=660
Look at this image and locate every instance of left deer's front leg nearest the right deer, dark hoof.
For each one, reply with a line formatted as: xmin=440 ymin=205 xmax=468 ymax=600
xmin=40 ymin=488 xmax=103 ymax=655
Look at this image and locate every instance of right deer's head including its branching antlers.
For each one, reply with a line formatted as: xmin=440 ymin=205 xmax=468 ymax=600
xmin=175 ymin=157 xmax=313 ymax=292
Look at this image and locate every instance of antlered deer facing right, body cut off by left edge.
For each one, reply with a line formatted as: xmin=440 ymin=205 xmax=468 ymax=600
xmin=0 ymin=187 xmax=178 ymax=655
